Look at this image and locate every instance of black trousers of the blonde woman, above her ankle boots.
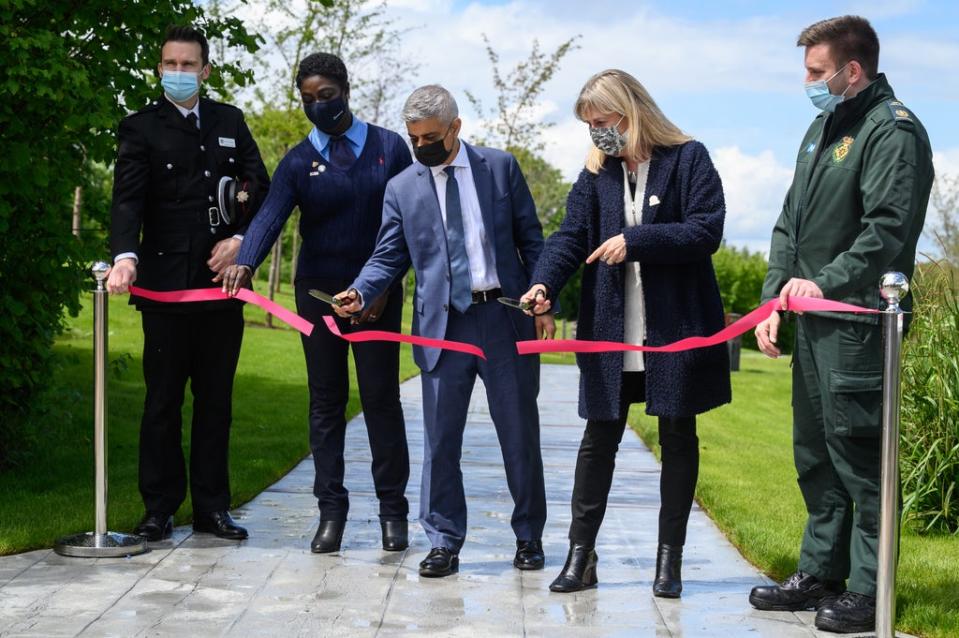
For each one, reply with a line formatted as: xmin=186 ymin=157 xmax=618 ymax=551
xmin=569 ymin=372 xmax=699 ymax=546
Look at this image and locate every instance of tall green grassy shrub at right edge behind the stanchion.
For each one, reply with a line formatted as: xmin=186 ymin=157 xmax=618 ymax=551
xmin=900 ymin=264 xmax=959 ymax=534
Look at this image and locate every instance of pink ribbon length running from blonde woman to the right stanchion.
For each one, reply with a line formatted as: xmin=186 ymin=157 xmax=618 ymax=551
xmin=516 ymin=296 xmax=880 ymax=354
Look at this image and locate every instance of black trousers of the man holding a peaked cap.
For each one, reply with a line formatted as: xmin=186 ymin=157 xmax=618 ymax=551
xmin=139 ymin=304 xmax=243 ymax=514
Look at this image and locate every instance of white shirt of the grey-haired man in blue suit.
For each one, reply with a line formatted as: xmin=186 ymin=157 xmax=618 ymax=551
xmin=430 ymin=142 xmax=500 ymax=290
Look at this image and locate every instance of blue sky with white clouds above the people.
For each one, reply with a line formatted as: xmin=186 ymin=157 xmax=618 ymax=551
xmin=236 ymin=0 xmax=959 ymax=252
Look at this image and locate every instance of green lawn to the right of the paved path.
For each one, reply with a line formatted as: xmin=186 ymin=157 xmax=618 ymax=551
xmin=630 ymin=351 xmax=959 ymax=638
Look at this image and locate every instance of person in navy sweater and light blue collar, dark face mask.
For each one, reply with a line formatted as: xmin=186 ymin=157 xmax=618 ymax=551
xmin=224 ymin=53 xmax=412 ymax=553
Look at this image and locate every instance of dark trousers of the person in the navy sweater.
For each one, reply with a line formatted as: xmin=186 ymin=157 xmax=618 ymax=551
xmin=296 ymin=279 xmax=410 ymax=521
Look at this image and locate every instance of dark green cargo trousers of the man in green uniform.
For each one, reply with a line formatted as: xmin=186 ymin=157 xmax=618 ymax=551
xmin=793 ymin=314 xmax=883 ymax=596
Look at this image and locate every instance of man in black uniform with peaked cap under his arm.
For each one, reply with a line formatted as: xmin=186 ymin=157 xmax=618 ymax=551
xmin=107 ymin=26 xmax=269 ymax=541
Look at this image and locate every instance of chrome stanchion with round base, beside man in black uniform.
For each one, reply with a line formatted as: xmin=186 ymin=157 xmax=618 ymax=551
xmin=53 ymin=261 xmax=147 ymax=558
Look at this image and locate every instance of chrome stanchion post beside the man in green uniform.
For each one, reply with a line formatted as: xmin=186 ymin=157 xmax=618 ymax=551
xmin=876 ymin=272 xmax=909 ymax=638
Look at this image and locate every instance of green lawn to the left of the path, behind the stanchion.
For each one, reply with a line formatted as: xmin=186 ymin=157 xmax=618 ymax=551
xmin=0 ymin=289 xmax=418 ymax=555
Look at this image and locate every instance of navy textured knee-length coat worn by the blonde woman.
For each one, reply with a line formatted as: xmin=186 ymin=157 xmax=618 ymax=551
xmin=532 ymin=141 xmax=731 ymax=421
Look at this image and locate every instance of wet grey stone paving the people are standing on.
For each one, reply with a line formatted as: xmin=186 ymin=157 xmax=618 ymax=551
xmin=0 ymin=366 xmax=908 ymax=638
